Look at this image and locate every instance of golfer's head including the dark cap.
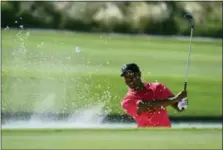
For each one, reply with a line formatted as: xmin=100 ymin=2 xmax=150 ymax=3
xmin=121 ymin=63 xmax=141 ymax=88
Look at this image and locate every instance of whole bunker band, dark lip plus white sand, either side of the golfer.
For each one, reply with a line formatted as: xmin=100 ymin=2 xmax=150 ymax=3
xmin=2 ymin=112 xmax=222 ymax=129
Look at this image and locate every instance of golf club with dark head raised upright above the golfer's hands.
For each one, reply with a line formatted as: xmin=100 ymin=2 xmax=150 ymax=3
xmin=184 ymin=14 xmax=194 ymax=91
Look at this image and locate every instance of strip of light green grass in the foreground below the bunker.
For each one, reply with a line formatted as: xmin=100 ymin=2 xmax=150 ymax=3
xmin=2 ymin=129 xmax=222 ymax=149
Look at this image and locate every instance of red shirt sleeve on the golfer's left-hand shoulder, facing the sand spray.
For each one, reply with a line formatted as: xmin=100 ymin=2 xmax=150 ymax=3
xmin=121 ymin=96 xmax=139 ymax=117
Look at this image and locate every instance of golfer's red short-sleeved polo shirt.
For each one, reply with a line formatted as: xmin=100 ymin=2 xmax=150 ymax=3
xmin=121 ymin=82 xmax=174 ymax=127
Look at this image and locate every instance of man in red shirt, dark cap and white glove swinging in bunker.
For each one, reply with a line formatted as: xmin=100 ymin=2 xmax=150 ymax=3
xmin=121 ymin=63 xmax=187 ymax=127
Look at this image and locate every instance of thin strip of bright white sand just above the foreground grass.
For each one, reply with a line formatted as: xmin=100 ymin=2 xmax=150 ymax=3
xmin=2 ymin=120 xmax=222 ymax=129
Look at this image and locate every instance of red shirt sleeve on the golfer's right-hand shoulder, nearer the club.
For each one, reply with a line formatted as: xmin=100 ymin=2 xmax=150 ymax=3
xmin=156 ymin=83 xmax=174 ymax=100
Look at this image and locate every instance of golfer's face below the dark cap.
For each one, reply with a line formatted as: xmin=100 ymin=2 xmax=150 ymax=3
xmin=124 ymin=72 xmax=139 ymax=88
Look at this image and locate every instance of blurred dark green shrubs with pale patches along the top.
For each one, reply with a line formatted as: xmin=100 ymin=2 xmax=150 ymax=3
xmin=1 ymin=1 xmax=222 ymax=38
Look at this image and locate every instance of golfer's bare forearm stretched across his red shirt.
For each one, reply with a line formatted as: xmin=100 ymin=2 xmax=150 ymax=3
xmin=137 ymin=97 xmax=178 ymax=113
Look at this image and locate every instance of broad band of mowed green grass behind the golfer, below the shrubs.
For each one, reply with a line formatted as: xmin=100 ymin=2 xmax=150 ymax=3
xmin=2 ymin=30 xmax=222 ymax=116
